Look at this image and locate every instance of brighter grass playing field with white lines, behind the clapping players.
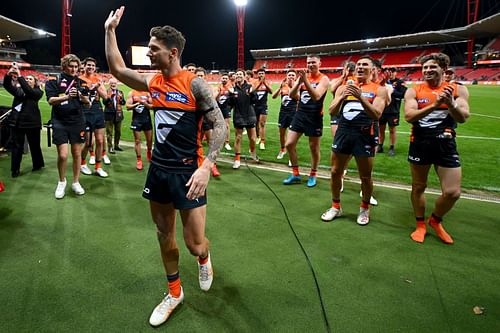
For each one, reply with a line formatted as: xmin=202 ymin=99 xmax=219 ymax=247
xmin=0 ymin=85 xmax=500 ymax=196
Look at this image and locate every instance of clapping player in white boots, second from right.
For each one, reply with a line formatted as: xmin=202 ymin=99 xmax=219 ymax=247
xmin=321 ymin=56 xmax=388 ymax=225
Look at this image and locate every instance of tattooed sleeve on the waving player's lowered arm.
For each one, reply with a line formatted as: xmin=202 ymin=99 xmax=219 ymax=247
xmin=191 ymin=78 xmax=226 ymax=163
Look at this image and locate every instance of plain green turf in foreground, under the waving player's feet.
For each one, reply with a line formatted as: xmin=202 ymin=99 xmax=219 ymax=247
xmin=0 ymin=142 xmax=500 ymax=333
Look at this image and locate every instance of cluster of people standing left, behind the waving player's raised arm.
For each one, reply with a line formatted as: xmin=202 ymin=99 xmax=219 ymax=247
xmin=45 ymin=54 xmax=157 ymax=199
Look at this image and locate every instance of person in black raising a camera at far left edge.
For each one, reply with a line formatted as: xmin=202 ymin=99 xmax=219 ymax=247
xmin=3 ymin=63 xmax=45 ymax=177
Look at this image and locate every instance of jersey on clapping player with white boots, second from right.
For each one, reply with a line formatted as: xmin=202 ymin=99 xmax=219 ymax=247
xmin=339 ymin=82 xmax=380 ymax=128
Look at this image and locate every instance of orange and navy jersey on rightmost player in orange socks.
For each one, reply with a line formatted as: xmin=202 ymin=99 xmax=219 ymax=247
xmin=412 ymin=82 xmax=458 ymax=137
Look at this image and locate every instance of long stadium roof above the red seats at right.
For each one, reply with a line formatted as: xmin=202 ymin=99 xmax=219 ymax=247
xmin=250 ymin=13 xmax=500 ymax=59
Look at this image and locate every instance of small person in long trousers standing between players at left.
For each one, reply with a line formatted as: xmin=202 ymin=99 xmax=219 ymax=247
xmin=104 ymin=78 xmax=125 ymax=154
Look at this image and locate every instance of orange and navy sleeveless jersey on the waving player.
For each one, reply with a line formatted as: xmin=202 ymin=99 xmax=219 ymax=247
xmin=149 ymin=71 xmax=203 ymax=173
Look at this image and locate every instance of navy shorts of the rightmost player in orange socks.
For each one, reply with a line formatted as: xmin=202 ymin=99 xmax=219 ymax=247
xmin=408 ymin=138 xmax=460 ymax=168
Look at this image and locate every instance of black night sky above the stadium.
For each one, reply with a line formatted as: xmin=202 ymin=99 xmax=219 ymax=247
xmin=0 ymin=0 xmax=500 ymax=69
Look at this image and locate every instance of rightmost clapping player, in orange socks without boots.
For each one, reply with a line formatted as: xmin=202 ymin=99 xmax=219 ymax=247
xmin=404 ymin=53 xmax=470 ymax=244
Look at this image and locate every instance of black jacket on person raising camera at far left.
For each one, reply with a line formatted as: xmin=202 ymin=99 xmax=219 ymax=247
xmin=3 ymin=75 xmax=43 ymax=128
